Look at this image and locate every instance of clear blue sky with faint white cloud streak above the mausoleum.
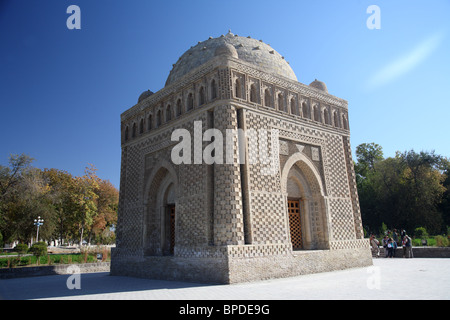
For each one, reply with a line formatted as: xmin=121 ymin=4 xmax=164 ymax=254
xmin=0 ymin=0 xmax=450 ymax=187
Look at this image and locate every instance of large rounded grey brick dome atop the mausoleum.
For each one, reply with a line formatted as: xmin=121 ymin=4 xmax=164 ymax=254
xmin=166 ymin=32 xmax=297 ymax=86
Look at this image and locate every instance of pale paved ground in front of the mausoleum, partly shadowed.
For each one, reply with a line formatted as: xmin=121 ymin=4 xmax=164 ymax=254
xmin=0 ymin=258 xmax=450 ymax=300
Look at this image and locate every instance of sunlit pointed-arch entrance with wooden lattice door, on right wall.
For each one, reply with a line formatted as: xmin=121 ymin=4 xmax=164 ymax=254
xmin=281 ymin=153 xmax=329 ymax=250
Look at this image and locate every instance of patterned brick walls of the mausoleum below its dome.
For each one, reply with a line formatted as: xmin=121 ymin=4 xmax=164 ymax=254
xmin=114 ymin=40 xmax=368 ymax=279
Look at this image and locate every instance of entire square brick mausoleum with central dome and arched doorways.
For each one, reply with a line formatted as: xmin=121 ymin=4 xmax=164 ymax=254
xmin=111 ymin=32 xmax=372 ymax=283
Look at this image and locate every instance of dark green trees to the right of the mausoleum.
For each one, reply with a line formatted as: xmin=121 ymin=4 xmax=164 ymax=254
xmin=355 ymin=143 xmax=450 ymax=234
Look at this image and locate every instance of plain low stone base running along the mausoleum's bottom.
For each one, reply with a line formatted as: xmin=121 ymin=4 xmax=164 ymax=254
xmin=111 ymin=242 xmax=372 ymax=284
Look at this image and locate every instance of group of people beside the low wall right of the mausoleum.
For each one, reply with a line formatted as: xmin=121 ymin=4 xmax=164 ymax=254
xmin=370 ymin=229 xmax=413 ymax=258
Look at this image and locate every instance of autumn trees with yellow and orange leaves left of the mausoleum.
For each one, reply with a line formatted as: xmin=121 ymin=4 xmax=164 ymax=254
xmin=0 ymin=154 xmax=118 ymax=243
